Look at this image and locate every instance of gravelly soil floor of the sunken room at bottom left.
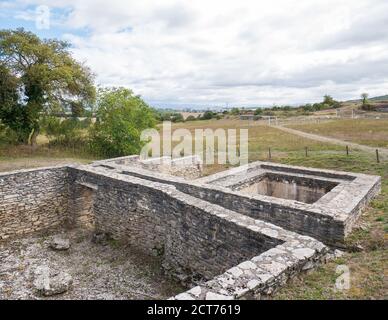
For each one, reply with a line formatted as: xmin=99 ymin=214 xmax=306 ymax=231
xmin=0 ymin=229 xmax=185 ymax=300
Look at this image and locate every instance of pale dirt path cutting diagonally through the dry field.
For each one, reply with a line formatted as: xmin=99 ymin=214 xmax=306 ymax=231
xmin=274 ymin=126 xmax=388 ymax=159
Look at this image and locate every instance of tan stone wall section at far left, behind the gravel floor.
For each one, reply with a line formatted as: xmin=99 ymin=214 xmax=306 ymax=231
xmin=0 ymin=167 xmax=68 ymax=240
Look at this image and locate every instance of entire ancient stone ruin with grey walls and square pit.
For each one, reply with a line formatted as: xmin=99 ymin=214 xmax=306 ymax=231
xmin=0 ymin=156 xmax=381 ymax=299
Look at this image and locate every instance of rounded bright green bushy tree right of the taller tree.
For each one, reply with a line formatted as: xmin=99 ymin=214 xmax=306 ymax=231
xmin=90 ymin=88 xmax=156 ymax=157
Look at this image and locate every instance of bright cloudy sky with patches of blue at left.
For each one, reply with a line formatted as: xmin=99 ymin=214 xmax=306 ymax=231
xmin=0 ymin=0 xmax=388 ymax=107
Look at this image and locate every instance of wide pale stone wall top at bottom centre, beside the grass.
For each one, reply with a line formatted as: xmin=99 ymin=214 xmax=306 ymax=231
xmin=171 ymin=240 xmax=329 ymax=300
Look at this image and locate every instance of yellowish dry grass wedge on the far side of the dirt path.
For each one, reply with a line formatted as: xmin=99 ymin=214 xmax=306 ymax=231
xmin=289 ymin=119 xmax=388 ymax=148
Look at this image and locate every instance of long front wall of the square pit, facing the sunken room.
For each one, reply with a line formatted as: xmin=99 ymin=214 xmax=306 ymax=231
xmin=109 ymin=168 xmax=345 ymax=245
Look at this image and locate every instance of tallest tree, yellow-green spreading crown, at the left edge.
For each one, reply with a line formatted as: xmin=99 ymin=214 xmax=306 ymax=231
xmin=0 ymin=29 xmax=95 ymax=145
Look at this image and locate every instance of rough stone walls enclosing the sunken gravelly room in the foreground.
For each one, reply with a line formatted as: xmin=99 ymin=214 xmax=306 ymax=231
xmin=0 ymin=165 xmax=327 ymax=299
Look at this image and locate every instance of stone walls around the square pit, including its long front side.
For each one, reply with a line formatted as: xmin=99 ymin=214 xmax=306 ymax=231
xmin=110 ymin=162 xmax=381 ymax=247
